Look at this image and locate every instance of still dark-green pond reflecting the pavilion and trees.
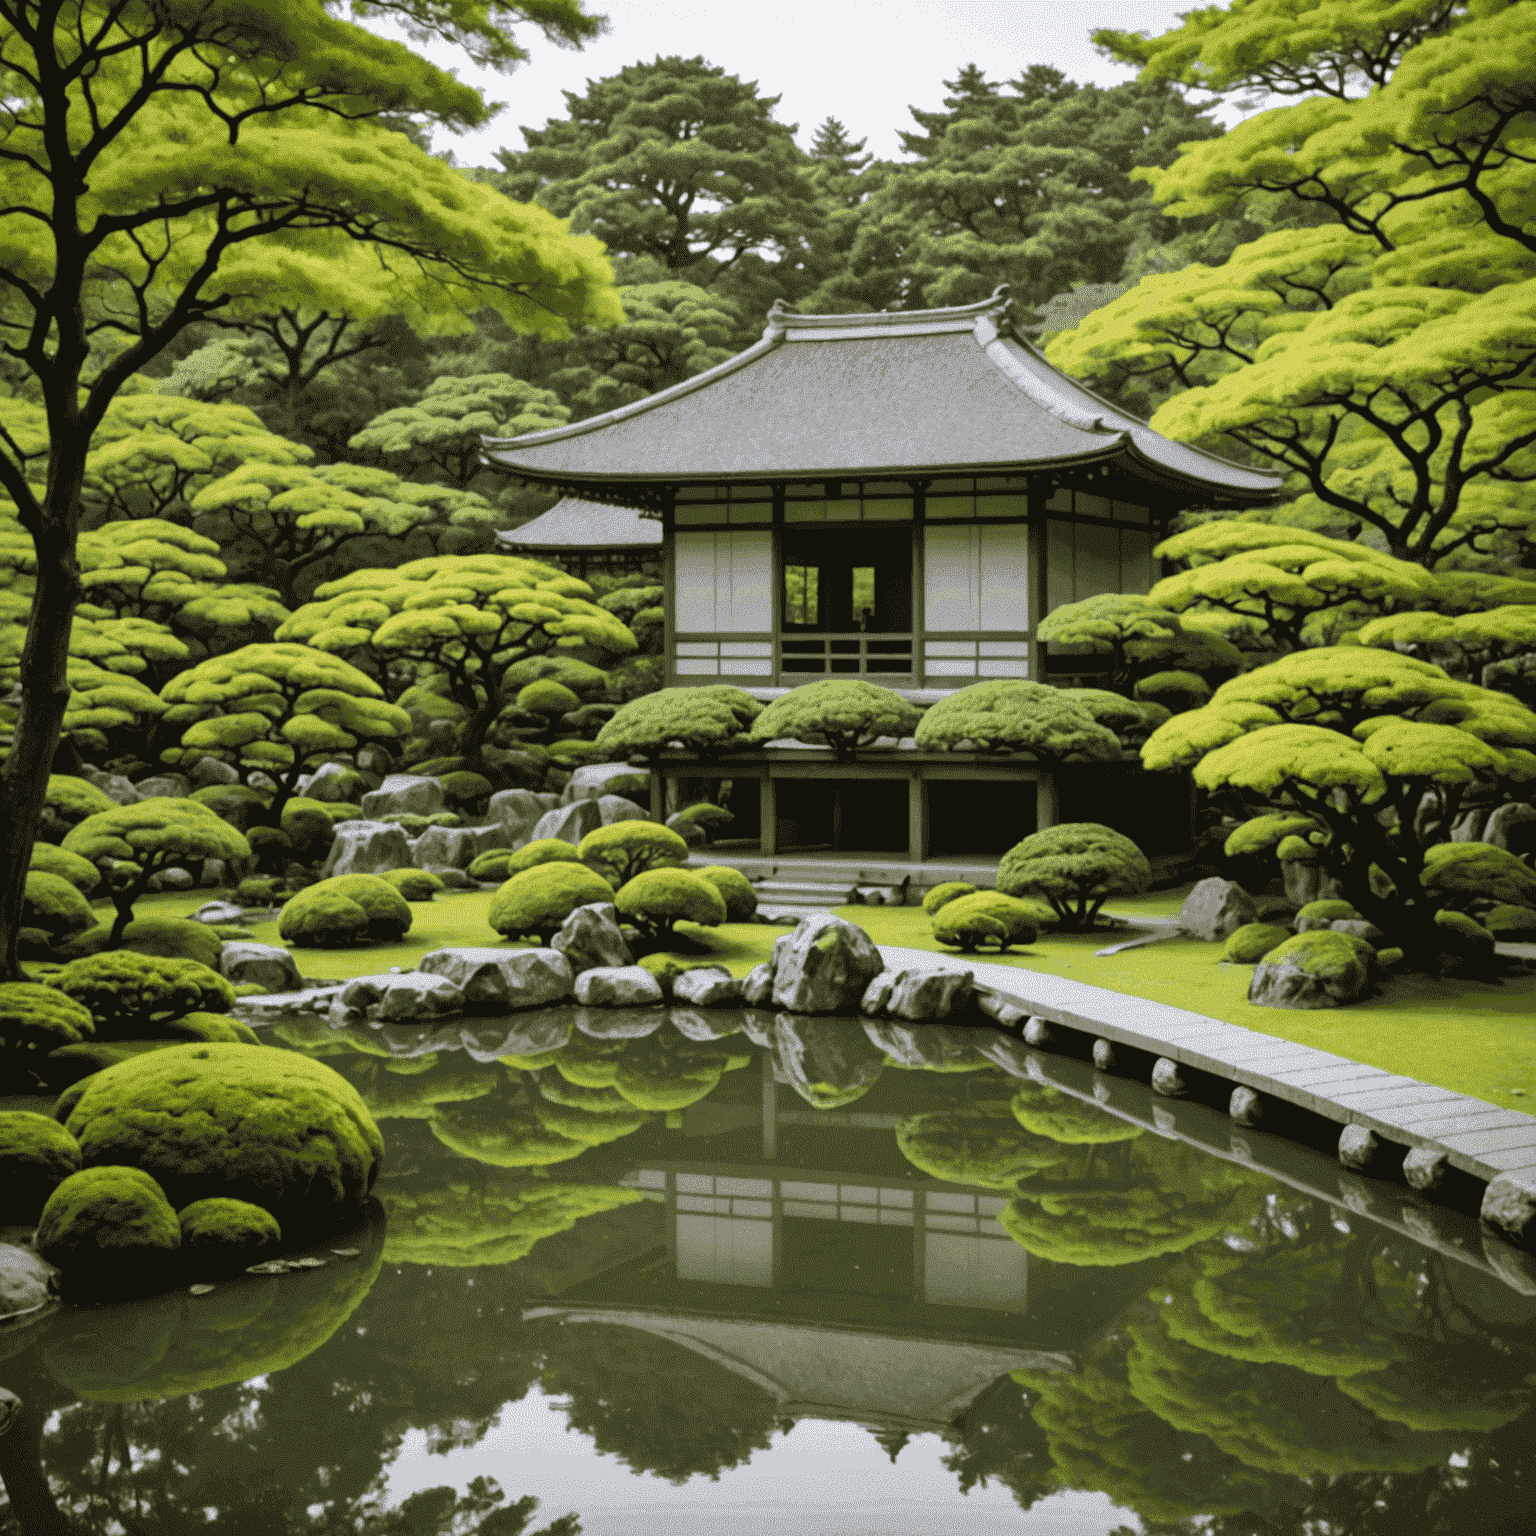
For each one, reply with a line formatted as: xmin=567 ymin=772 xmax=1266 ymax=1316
xmin=0 ymin=1011 xmax=1536 ymax=1536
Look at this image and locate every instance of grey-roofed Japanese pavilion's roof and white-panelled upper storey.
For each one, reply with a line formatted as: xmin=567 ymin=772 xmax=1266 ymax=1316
xmin=484 ymin=290 xmax=1279 ymax=690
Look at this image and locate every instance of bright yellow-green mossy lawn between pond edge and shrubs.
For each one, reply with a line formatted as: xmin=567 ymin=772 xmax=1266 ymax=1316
xmin=140 ymin=891 xmax=1536 ymax=1112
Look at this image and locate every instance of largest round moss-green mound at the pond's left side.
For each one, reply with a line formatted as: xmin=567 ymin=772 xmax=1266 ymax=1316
xmin=66 ymin=1044 xmax=384 ymax=1238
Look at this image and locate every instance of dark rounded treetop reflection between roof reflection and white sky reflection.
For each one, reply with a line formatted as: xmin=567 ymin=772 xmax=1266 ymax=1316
xmin=544 ymin=1322 xmax=779 ymax=1482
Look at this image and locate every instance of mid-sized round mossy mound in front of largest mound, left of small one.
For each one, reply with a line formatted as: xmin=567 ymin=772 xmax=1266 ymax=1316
xmin=34 ymin=1163 xmax=181 ymax=1295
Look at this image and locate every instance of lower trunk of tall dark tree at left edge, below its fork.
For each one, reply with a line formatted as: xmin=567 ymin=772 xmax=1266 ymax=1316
xmin=0 ymin=509 xmax=84 ymax=982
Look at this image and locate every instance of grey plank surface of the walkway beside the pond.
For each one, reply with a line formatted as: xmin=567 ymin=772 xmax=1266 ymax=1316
xmin=880 ymin=945 xmax=1536 ymax=1186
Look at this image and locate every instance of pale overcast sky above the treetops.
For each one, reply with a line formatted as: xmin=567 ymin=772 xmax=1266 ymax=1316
xmin=379 ymin=0 xmax=1230 ymax=166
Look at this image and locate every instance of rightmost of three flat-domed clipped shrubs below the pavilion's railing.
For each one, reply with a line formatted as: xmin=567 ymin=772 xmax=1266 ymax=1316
xmin=915 ymin=682 xmax=1120 ymax=763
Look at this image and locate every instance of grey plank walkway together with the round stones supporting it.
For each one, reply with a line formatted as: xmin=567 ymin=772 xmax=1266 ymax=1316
xmin=880 ymin=945 xmax=1536 ymax=1249
